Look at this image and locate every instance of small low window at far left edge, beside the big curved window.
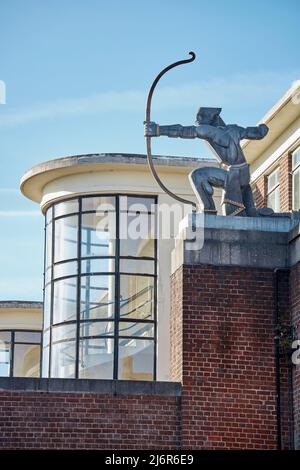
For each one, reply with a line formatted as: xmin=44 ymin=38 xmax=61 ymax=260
xmin=0 ymin=330 xmax=42 ymax=377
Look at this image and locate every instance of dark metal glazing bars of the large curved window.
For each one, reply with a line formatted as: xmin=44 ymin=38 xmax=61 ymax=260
xmin=41 ymin=193 xmax=158 ymax=381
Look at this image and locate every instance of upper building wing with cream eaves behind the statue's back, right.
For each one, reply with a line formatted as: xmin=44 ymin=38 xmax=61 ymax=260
xmin=243 ymin=81 xmax=300 ymax=212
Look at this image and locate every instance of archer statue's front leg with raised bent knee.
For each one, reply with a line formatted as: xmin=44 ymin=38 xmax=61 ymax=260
xmin=189 ymin=168 xmax=226 ymax=214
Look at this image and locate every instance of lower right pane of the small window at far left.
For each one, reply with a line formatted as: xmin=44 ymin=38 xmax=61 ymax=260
xmin=13 ymin=344 xmax=41 ymax=377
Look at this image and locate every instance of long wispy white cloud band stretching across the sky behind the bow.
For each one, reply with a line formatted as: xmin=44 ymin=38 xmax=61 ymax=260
xmin=0 ymin=71 xmax=299 ymax=127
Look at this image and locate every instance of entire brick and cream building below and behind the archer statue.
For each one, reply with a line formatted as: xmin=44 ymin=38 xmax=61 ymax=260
xmin=0 ymin=83 xmax=300 ymax=449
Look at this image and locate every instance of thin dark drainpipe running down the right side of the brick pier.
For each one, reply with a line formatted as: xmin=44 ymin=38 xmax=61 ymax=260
xmin=273 ymin=268 xmax=290 ymax=450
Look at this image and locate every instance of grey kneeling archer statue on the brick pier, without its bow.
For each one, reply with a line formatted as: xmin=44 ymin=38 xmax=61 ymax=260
xmin=145 ymin=107 xmax=273 ymax=217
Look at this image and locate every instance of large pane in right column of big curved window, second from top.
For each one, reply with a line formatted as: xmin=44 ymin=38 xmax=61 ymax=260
xmin=120 ymin=214 xmax=155 ymax=258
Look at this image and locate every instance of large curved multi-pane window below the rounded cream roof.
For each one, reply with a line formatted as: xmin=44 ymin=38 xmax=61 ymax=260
xmin=42 ymin=195 xmax=157 ymax=380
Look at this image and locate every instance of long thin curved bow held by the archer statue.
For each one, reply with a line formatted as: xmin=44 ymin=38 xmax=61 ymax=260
xmin=146 ymin=52 xmax=196 ymax=207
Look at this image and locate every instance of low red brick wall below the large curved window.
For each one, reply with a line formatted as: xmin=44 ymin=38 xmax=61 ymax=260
xmin=0 ymin=391 xmax=180 ymax=450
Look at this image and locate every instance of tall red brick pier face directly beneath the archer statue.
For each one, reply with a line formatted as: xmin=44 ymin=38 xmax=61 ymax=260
xmin=173 ymin=265 xmax=284 ymax=449
